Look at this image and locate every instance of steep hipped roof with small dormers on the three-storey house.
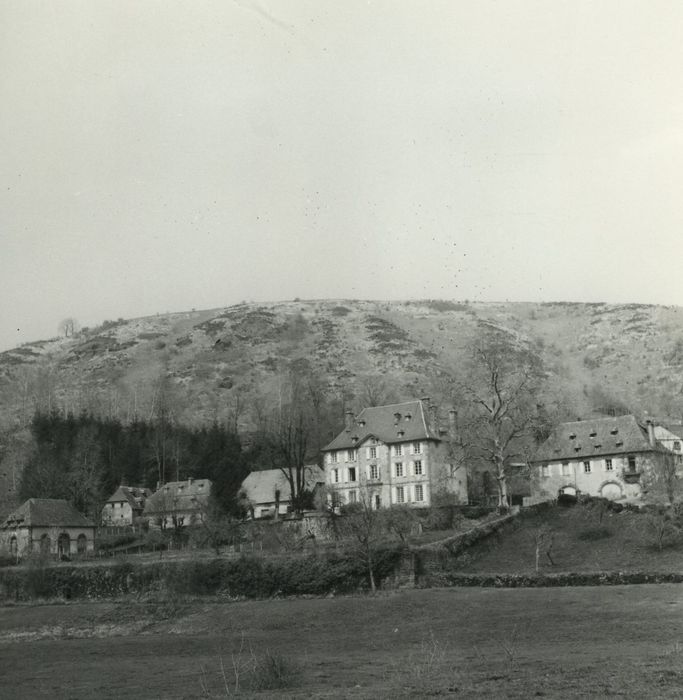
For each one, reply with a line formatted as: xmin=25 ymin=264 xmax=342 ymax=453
xmin=323 ymin=400 xmax=441 ymax=450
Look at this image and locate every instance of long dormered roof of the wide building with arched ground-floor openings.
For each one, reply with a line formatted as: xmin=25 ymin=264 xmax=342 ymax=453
xmin=532 ymin=416 xmax=663 ymax=462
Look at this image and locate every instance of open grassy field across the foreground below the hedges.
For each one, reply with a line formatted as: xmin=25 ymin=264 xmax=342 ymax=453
xmin=0 ymin=585 xmax=683 ymax=699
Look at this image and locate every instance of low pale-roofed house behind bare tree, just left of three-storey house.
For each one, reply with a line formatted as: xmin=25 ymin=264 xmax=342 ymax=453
xmin=240 ymin=464 xmax=325 ymax=518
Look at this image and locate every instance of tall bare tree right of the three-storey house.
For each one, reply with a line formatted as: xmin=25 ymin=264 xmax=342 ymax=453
xmin=454 ymin=331 xmax=543 ymax=508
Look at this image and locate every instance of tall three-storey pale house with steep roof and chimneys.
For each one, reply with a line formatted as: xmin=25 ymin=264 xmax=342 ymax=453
xmin=323 ymin=398 xmax=467 ymax=508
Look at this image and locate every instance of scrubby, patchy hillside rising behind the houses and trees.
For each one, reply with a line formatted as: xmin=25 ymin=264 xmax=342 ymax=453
xmin=0 ymin=300 xmax=683 ymax=431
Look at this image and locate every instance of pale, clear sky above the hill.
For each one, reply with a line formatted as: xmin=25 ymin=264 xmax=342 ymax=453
xmin=0 ymin=0 xmax=683 ymax=350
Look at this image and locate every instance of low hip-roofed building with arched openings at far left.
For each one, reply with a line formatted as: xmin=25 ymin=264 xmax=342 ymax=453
xmin=0 ymin=498 xmax=95 ymax=558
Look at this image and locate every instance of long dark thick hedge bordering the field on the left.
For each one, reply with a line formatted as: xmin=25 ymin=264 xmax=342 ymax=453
xmin=0 ymin=548 xmax=402 ymax=600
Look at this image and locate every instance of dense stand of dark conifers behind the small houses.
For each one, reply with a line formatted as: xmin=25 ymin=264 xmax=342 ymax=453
xmin=19 ymin=411 xmax=249 ymax=516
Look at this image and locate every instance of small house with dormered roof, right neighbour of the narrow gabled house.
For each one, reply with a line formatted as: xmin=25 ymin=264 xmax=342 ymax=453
xmin=143 ymin=478 xmax=211 ymax=530
